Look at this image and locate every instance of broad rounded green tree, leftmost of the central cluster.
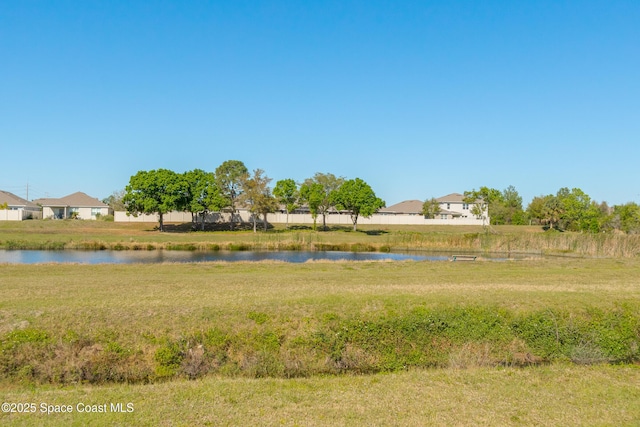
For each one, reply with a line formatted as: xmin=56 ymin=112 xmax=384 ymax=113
xmin=123 ymin=169 xmax=188 ymax=231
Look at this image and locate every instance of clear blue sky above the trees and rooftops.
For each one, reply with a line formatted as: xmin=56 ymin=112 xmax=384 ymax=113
xmin=0 ymin=0 xmax=640 ymax=207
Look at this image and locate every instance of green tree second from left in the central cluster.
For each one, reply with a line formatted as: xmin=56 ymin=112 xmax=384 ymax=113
xmin=184 ymin=169 xmax=226 ymax=230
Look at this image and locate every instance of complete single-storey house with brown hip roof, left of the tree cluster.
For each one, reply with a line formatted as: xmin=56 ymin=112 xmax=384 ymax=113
xmin=34 ymin=191 xmax=112 ymax=219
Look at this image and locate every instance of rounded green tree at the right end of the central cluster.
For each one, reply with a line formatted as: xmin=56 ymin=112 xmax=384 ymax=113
xmin=333 ymin=178 xmax=385 ymax=231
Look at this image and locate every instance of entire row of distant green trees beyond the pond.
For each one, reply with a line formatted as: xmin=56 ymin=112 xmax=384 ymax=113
xmin=104 ymin=160 xmax=640 ymax=234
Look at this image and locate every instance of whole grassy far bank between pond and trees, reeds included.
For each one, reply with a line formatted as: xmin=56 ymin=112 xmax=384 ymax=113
xmin=0 ymin=221 xmax=640 ymax=258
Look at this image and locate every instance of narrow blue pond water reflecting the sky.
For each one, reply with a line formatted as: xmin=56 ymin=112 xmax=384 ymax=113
xmin=0 ymin=250 xmax=449 ymax=264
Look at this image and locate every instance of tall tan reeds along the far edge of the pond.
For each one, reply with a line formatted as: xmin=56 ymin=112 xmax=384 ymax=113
xmin=0 ymin=232 xmax=640 ymax=258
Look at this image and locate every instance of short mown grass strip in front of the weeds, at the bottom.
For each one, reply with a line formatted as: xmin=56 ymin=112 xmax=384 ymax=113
xmin=0 ymin=365 xmax=640 ymax=426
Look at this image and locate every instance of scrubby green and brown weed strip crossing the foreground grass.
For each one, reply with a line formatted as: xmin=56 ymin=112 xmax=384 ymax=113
xmin=0 ymin=305 xmax=640 ymax=384
